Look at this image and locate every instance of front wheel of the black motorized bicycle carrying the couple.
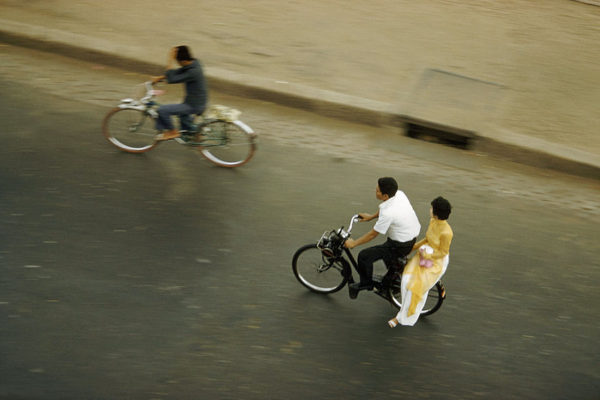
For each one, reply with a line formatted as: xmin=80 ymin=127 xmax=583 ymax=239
xmin=292 ymin=244 xmax=348 ymax=293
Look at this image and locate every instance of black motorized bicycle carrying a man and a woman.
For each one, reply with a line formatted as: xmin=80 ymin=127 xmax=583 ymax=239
xmin=292 ymin=214 xmax=446 ymax=316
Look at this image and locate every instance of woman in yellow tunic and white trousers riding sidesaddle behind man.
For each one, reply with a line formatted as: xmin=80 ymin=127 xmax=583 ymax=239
xmin=388 ymin=197 xmax=453 ymax=328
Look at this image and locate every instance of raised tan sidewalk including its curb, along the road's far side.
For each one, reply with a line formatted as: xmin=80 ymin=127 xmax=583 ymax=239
xmin=0 ymin=0 xmax=600 ymax=178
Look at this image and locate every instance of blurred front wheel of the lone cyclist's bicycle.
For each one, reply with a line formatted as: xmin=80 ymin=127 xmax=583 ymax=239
xmin=102 ymin=108 xmax=158 ymax=153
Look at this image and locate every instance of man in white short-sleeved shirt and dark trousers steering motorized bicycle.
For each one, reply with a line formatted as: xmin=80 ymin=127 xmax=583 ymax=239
xmin=345 ymin=177 xmax=421 ymax=299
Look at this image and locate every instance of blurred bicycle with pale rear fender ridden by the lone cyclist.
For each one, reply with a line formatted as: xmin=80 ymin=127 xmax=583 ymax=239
xmin=102 ymin=82 xmax=257 ymax=168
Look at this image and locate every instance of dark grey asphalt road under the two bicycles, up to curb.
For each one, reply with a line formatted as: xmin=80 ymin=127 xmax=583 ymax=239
xmin=0 ymin=44 xmax=600 ymax=399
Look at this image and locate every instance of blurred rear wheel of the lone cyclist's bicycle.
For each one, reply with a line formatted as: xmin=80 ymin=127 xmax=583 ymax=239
xmin=200 ymin=120 xmax=256 ymax=168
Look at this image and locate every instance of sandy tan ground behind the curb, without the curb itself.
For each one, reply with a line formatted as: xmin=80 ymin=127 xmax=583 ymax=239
xmin=0 ymin=0 xmax=600 ymax=154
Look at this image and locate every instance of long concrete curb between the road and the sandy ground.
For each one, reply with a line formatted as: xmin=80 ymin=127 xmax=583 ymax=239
xmin=0 ymin=19 xmax=600 ymax=179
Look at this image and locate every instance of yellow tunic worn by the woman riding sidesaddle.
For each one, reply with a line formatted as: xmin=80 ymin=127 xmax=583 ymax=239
xmin=403 ymin=218 xmax=453 ymax=316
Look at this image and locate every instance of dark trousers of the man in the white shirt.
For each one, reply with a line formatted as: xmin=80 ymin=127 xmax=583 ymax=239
xmin=356 ymin=238 xmax=417 ymax=285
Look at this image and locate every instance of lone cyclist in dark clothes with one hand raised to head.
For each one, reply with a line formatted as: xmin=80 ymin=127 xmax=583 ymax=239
xmin=152 ymin=46 xmax=208 ymax=140
